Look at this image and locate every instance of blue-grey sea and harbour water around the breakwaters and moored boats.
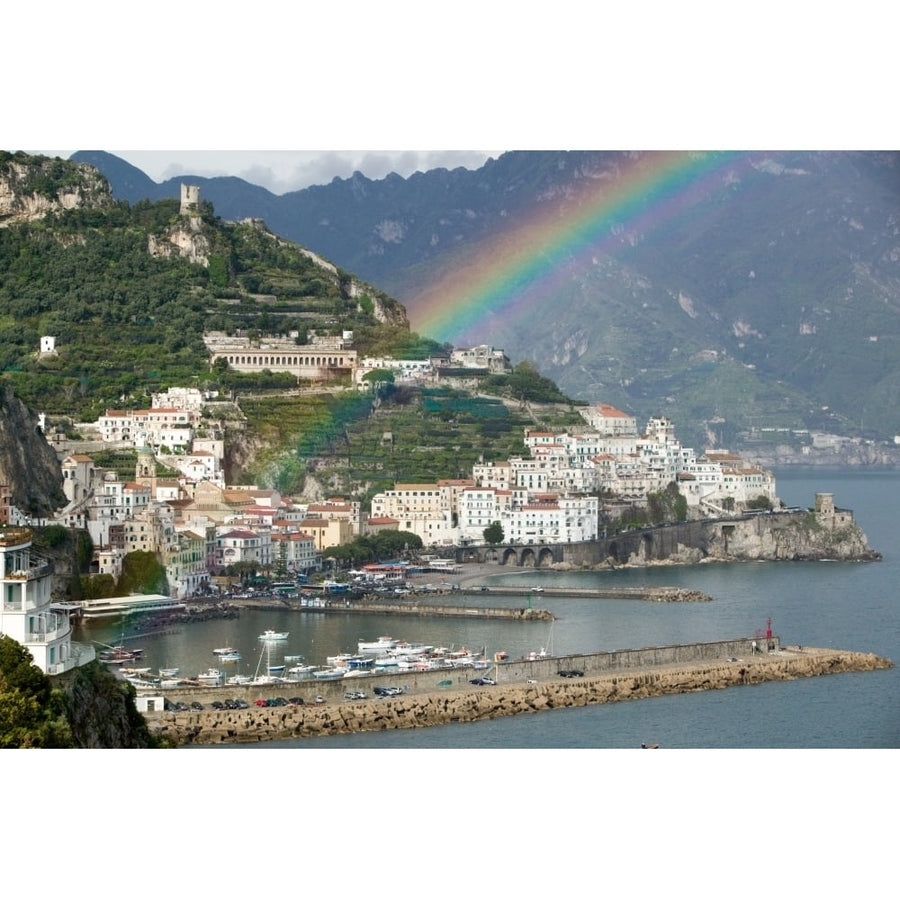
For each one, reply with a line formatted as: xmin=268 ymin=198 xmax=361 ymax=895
xmin=72 ymin=470 xmax=900 ymax=748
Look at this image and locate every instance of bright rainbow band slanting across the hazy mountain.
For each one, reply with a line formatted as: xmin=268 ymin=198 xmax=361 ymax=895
xmin=407 ymin=151 xmax=742 ymax=343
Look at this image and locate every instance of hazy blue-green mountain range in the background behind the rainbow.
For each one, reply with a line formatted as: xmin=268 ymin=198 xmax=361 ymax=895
xmin=73 ymin=151 xmax=900 ymax=454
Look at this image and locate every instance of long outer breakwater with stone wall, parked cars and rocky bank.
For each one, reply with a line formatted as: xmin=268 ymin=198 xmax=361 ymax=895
xmin=146 ymin=639 xmax=893 ymax=746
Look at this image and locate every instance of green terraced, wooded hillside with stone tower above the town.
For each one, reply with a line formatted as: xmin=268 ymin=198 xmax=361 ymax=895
xmin=0 ymin=154 xmax=581 ymax=496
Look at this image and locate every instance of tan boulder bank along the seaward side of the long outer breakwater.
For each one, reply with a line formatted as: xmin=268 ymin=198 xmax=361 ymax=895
xmin=147 ymin=647 xmax=893 ymax=746
